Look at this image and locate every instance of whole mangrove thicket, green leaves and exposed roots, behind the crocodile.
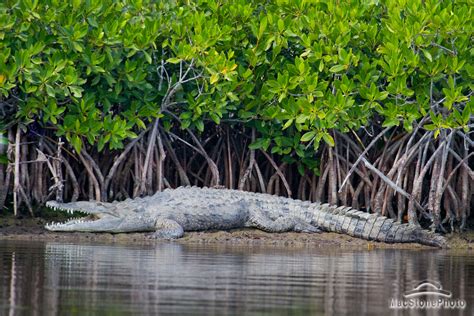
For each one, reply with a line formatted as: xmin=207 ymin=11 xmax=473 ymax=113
xmin=0 ymin=0 xmax=474 ymax=230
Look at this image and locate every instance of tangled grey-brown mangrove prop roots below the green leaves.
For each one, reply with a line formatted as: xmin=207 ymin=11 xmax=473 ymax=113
xmin=0 ymin=123 xmax=474 ymax=230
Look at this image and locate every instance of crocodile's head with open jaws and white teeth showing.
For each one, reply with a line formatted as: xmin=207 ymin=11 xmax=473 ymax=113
xmin=45 ymin=201 xmax=154 ymax=233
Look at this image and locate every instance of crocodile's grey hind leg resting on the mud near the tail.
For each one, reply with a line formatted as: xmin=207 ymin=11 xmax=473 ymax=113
xmin=246 ymin=214 xmax=321 ymax=233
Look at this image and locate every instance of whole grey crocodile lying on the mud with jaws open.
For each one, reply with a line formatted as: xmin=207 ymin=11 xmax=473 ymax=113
xmin=45 ymin=187 xmax=447 ymax=247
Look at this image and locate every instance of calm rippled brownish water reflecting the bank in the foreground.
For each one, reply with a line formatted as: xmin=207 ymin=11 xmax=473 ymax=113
xmin=0 ymin=241 xmax=474 ymax=315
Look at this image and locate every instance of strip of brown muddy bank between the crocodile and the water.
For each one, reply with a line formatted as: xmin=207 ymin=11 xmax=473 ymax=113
xmin=0 ymin=217 xmax=474 ymax=250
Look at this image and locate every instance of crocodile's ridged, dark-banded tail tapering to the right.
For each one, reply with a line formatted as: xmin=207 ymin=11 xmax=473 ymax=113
xmin=315 ymin=204 xmax=447 ymax=248
